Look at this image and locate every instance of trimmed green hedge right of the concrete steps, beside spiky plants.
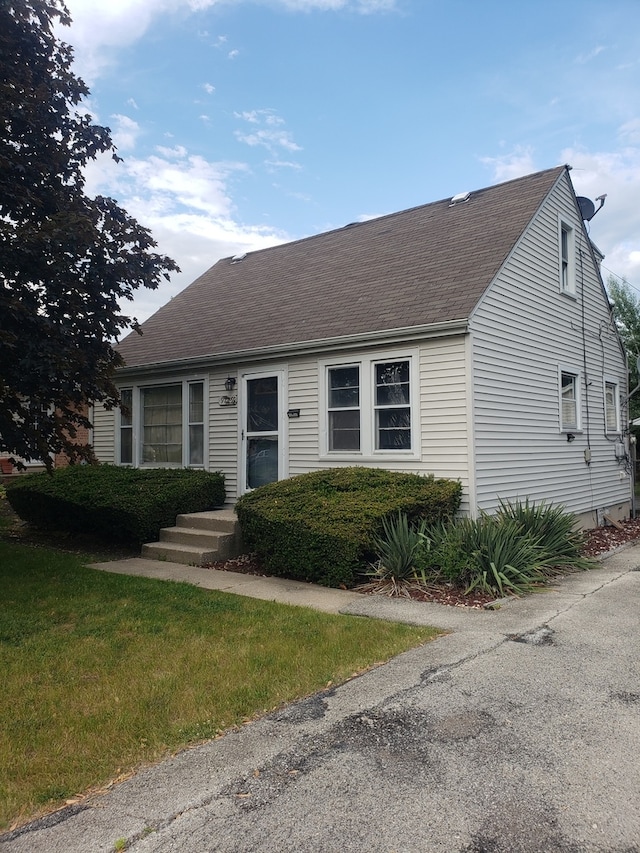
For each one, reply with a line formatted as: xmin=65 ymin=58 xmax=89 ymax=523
xmin=236 ymin=467 xmax=462 ymax=587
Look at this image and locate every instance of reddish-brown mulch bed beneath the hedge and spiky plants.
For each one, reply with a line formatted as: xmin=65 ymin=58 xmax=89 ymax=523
xmin=205 ymin=518 xmax=640 ymax=610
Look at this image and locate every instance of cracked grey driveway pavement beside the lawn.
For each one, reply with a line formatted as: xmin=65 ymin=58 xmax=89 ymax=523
xmin=0 ymin=546 xmax=640 ymax=853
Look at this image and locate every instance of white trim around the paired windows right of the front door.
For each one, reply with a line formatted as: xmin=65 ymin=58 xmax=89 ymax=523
xmin=318 ymin=348 xmax=420 ymax=463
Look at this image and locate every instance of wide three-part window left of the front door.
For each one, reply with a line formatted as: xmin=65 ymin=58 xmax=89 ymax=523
xmin=118 ymin=381 xmax=205 ymax=467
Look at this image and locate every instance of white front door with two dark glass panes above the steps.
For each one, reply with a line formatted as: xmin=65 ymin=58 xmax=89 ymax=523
xmin=242 ymin=373 xmax=284 ymax=492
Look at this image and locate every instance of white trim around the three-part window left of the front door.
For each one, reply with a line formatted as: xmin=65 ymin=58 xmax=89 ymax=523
xmin=115 ymin=375 xmax=209 ymax=471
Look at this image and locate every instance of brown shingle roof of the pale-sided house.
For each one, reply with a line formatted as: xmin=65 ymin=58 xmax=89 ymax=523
xmin=118 ymin=166 xmax=567 ymax=367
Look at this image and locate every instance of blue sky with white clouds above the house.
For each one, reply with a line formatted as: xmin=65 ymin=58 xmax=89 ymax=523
xmin=62 ymin=0 xmax=640 ymax=320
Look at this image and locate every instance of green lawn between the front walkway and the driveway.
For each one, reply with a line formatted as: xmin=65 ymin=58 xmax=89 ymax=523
xmin=0 ymin=541 xmax=436 ymax=829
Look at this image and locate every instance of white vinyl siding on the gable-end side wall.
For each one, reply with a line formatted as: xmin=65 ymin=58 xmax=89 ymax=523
xmin=471 ymin=178 xmax=630 ymax=514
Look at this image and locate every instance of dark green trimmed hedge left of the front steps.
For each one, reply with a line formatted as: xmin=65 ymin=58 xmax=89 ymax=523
xmin=7 ymin=465 xmax=225 ymax=544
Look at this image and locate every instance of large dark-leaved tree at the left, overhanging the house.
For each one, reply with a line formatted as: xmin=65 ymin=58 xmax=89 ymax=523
xmin=0 ymin=0 xmax=178 ymax=465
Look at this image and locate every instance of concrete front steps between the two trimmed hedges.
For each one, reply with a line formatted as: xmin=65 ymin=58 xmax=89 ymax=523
xmin=142 ymin=509 xmax=242 ymax=566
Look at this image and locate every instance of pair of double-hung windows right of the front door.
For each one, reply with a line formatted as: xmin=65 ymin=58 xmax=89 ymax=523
xmin=323 ymin=354 xmax=417 ymax=458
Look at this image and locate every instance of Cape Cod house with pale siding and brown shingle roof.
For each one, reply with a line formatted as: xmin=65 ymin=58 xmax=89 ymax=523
xmin=93 ymin=166 xmax=631 ymax=526
